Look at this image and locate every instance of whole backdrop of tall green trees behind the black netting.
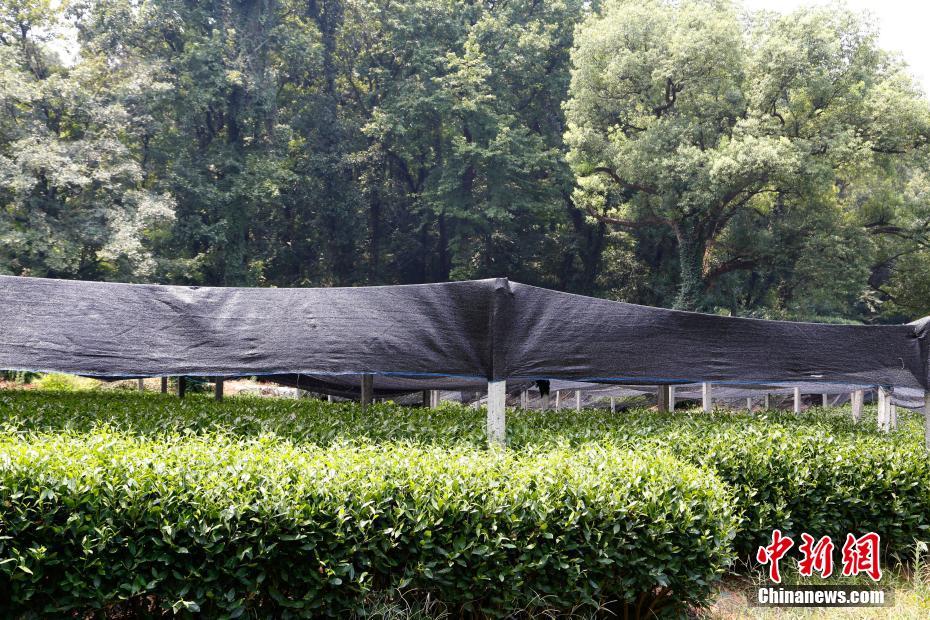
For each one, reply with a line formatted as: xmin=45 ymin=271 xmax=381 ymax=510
xmin=0 ymin=0 xmax=930 ymax=321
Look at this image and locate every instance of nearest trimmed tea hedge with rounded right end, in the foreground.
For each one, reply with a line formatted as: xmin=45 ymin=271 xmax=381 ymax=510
xmin=0 ymin=426 xmax=736 ymax=617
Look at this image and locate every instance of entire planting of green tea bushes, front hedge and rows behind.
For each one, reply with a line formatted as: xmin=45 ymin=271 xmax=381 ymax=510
xmin=0 ymin=392 xmax=930 ymax=617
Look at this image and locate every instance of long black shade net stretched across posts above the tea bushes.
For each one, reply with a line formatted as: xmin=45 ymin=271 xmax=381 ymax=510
xmin=0 ymin=276 xmax=928 ymax=392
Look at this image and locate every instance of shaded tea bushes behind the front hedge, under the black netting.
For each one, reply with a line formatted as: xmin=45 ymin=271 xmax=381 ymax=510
xmin=0 ymin=392 xmax=930 ymax=568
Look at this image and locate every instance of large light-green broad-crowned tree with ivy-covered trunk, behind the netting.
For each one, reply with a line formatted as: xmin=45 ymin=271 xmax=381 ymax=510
xmin=566 ymin=0 xmax=930 ymax=309
